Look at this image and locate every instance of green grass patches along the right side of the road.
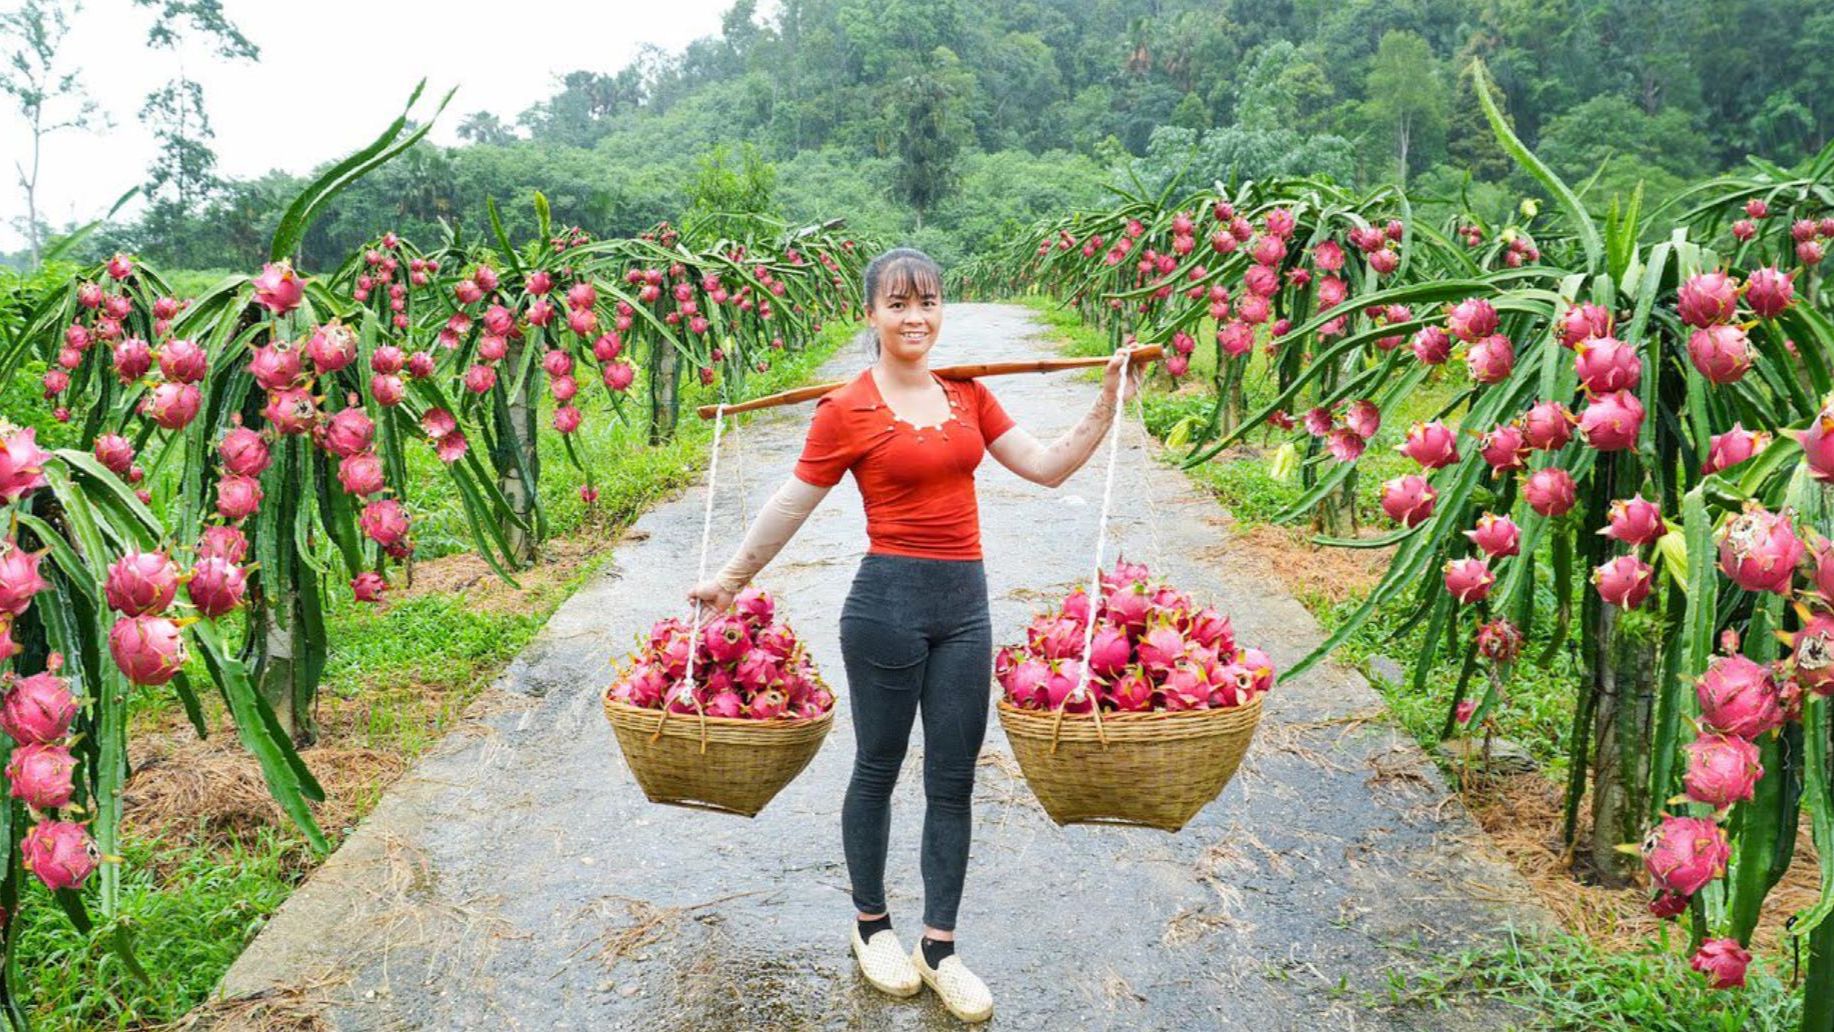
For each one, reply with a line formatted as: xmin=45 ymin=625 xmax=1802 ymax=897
xmin=1022 ymin=297 xmax=1801 ymax=1032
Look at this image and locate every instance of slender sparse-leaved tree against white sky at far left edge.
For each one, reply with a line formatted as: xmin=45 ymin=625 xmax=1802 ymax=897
xmin=0 ymin=0 xmax=108 ymax=268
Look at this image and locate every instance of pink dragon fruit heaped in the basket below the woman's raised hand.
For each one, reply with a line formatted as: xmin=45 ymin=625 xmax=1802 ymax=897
xmin=994 ymin=561 xmax=1275 ymax=713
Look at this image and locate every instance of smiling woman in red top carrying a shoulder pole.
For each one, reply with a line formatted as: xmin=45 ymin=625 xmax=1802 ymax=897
xmin=688 ymin=247 xmax=1139 ymax=1021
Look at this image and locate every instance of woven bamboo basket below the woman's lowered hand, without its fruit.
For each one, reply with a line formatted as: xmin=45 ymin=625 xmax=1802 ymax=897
xmin=605 ymin=697 xmax=834 ymax=818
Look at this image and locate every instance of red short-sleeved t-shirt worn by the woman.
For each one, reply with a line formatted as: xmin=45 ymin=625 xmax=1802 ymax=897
xmin=796 ymin=368 xmax=1012 ymax=559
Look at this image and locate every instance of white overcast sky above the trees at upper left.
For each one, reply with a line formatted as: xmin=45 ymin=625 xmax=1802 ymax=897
xmin=0 ymin=0 xmax=744 ymax=251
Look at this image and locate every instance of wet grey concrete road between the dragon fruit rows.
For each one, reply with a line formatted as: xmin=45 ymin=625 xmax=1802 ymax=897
xmin=210 ymin=304 xmax=1542 ymax=1030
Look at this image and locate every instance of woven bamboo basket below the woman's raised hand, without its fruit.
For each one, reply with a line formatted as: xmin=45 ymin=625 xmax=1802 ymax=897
xmin=1000 ymin=695 xmax=1262 ymax=832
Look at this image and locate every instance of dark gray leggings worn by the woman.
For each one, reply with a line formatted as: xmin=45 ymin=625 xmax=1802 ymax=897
xmin=840 ymin=554 xmax=994 ymax=931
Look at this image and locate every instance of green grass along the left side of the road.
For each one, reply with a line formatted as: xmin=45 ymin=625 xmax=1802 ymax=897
xmin=15 ymin=324 xmax=847 ymax=1030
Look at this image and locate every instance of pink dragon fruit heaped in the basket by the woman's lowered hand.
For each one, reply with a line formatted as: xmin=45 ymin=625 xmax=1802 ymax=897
xmin=609 ymin=588 xmax=834 ymax=720
